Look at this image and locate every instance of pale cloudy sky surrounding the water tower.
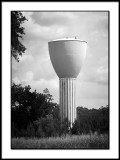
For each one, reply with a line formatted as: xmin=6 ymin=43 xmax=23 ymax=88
xmin=12 ymin=12 xmax=108 ymax=108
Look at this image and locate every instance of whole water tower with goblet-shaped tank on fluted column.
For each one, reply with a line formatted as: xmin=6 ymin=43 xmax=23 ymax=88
xmin=48 ymin=38 xmax=87 ymax=126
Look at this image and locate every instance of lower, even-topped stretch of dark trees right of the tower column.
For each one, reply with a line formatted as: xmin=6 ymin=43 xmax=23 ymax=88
xmin=73 ymin=105 xmax=109 ymax=134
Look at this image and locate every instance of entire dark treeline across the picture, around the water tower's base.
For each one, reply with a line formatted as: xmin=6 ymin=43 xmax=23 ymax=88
xmin=11 ymin=83 xmax=109 ymax=137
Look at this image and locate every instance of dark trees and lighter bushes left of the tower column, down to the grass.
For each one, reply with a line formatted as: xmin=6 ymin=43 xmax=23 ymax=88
xmin=11 ymin=83 xmax=60 ymax=137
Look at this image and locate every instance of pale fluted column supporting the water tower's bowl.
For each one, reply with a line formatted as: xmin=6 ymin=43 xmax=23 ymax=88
xmin=59 ymin=78 xmax=76 ymax=127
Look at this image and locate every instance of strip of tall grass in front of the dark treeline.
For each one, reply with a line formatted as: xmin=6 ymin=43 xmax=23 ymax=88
xmin=11 ymin=134 xmax=109 ymax=149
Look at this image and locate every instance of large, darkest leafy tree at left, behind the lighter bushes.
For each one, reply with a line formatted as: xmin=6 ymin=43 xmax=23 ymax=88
xmin=11 ymin=83 xmax=56 ymax=132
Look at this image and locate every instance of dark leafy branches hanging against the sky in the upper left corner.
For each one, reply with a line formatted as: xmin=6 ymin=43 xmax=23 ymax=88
xmin=11 ymin=11 xmax=27 ymax=62
